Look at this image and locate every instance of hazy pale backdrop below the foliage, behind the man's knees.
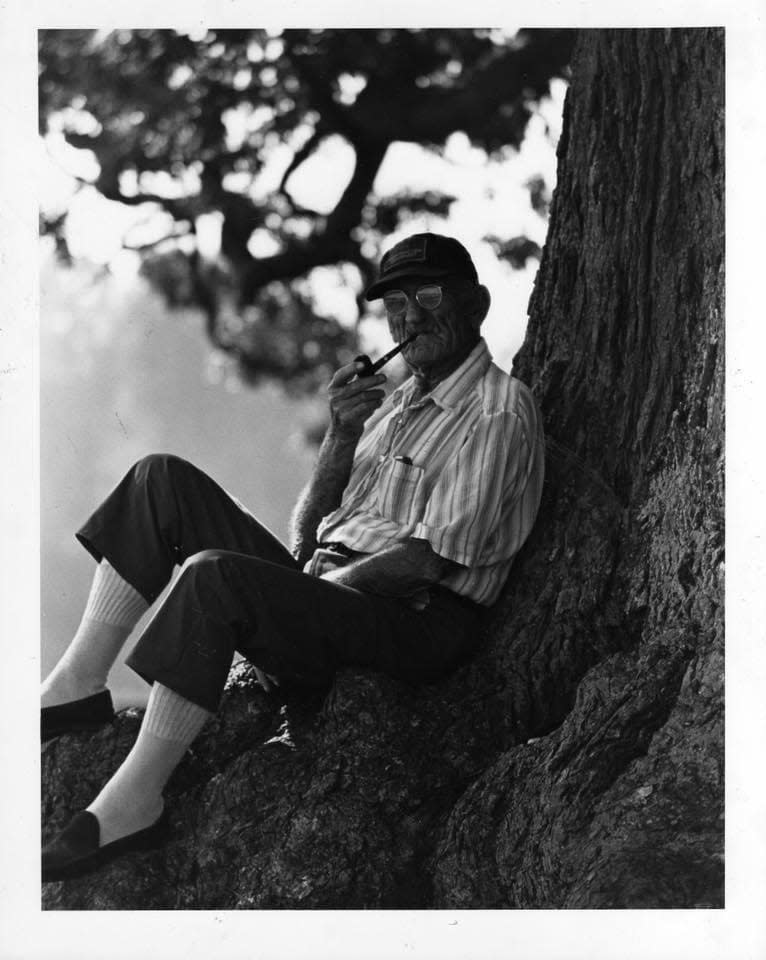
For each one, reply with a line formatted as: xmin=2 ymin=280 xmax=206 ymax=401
xmin=40 ymin=256 xmax=314 ymax=709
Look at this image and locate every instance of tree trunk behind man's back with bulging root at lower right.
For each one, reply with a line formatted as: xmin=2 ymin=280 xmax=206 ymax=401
xmin=436 ymin=24 xmax=724 ymax=907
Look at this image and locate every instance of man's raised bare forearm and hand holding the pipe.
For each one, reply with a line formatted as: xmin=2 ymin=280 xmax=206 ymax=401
xmin=291 ymin=362 xmax=386 ymax=564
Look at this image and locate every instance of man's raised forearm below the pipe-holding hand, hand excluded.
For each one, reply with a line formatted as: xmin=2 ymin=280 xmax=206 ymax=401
xmin=291 ymin=427 xmax=358 ymax=564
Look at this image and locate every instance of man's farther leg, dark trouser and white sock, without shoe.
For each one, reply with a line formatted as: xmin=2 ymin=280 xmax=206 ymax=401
xmin=41 ymin=454 xmax=296 ymax=720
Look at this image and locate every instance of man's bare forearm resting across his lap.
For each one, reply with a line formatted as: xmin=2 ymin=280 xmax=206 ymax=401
xmin=325 ymin=540 xmax=456 ymax=597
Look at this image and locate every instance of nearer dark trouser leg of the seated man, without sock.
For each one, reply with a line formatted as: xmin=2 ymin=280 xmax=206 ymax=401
xmin=127 ymin=550 xmax=479 ymax=712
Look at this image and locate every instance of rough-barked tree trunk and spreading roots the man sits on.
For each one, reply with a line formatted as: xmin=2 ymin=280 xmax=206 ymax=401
xmin=43 ymin=30 xmax=724 ymax=909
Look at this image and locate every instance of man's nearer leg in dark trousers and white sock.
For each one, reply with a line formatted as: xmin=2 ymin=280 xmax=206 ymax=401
xmin=43 ymin=550 xmax=478 ymax=878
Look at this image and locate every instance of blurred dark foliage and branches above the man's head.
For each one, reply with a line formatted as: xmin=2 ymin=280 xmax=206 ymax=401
xmin=39 ymin=29 xmax=572 ymax=384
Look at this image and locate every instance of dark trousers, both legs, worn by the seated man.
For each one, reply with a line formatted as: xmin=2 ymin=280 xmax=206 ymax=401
xmin=77 ymin=454 xmax=480 ymax=711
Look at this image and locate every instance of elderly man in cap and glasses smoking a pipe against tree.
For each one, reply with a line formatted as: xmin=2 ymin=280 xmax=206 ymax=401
xmin=41 ymin=233 xmax=544 ymax=880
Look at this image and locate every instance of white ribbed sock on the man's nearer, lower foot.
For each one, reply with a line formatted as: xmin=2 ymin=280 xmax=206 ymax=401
xmin=88 ymin=683 xmax=213 ymax=846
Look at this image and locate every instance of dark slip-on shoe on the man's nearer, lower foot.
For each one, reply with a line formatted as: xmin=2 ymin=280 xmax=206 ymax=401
xmin=42 ymin=810 xmax=168 ymax=883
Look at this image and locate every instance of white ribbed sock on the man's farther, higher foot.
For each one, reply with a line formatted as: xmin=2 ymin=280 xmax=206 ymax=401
xmin=41 ymin=560 xmax=148 ymax=707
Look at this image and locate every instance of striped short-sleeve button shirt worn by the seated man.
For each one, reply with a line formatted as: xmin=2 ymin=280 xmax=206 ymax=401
xmin=317 ymin=340 xmax=545 ymax=604
